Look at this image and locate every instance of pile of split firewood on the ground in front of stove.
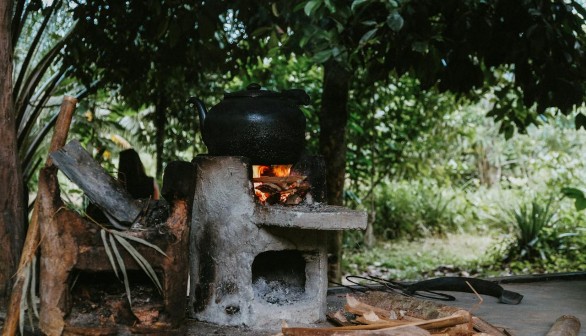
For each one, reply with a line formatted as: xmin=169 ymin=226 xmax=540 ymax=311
xmin=281 ymin=295 xmax=506 ymax=336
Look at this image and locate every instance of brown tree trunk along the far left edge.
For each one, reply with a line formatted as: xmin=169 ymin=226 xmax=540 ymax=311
xmin=0 ymin=1 xmax=26 ymax=300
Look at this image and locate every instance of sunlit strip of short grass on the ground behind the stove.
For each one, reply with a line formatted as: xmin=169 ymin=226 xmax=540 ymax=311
xmin=342 ymin=233 xmax=496 ymax=280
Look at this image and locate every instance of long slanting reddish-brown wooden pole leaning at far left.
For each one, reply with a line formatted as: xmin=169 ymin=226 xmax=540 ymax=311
xmin=2 ymin=96 xmax=77 ymax=336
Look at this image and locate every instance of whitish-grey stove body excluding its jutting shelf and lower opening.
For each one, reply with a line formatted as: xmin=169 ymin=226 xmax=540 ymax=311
xmin=189 ymin=156 xmax=327 ymax=329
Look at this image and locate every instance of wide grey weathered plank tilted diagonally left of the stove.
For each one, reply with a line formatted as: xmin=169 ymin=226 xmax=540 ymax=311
xmin=51 ymin=140 xmax=141 ymax=224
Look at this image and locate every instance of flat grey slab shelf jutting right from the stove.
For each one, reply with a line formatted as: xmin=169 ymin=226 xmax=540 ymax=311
xmin=254 ymin=204 xmax=367 ymax=230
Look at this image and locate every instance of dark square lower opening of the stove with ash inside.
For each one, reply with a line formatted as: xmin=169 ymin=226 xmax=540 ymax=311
xmin=252 ymin=250 xmax=306 ymax=305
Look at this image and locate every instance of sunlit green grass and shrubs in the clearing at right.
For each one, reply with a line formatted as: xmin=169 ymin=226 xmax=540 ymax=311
xmin=344 ymin=111 xmax=586 ymax=279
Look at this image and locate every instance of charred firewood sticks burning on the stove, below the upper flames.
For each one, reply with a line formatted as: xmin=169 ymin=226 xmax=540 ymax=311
xmin=252 ymin=175 xmax=311 ymax=205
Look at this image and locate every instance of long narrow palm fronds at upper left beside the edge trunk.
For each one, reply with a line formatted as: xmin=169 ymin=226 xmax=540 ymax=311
xmin=12 ymin=0 xmax=92 ymax=185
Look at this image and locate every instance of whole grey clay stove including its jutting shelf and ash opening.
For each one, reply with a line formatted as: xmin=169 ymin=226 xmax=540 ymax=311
xmin=189 ymin=155 xmax=366 ymax=328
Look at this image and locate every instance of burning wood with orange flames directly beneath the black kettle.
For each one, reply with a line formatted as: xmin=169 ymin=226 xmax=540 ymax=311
xmin=252 ymin=165 xmax=311 ymax=205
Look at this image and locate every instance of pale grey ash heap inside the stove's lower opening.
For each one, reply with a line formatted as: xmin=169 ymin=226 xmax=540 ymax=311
xmin=252 ymin=277 xmax=305 ymax=305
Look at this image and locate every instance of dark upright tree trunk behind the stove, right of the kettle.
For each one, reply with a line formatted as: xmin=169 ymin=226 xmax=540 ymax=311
xmin=319 ymin=62 xmax=350 ymax=282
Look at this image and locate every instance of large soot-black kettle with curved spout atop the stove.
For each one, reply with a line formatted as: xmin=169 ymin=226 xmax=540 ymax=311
xmin=189 ymin=84 xmax=309 ymax=165
